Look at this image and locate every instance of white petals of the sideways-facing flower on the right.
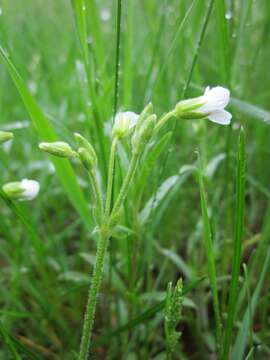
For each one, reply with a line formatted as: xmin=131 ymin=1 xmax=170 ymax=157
xmin=196 ymin=86 xmax=232 ymax=125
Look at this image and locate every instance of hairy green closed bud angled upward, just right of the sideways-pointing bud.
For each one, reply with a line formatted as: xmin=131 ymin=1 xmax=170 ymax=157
xmin=74 ymin=133 xmax=97 ymax=170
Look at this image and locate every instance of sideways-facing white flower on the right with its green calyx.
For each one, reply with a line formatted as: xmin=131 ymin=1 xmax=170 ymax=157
xmin=175 ymin=86 xmax=232 ymax=125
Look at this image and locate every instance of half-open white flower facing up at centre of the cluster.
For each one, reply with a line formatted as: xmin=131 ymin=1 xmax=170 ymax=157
xmin=112 ymin=111 xmax=139 ymax=139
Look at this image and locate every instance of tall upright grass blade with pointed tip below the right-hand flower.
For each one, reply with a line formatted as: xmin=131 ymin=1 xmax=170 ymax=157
xmin=222 ymin=128 xmax=246 ymax=360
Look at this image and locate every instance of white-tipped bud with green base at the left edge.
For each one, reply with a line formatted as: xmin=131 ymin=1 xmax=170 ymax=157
xmin=2 ymin=179 xmax=39 ymax=201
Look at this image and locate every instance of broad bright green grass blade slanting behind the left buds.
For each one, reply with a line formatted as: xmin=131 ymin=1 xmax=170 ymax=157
xmin=0 ymin=46 xmax=91 ymax=226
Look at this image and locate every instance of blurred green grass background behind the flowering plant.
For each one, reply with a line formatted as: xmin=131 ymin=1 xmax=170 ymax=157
xmin=0 ymin=0 xmax=270 ymax=359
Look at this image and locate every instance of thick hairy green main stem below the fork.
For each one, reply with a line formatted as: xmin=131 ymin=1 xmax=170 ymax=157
xmin=78 ymin=229 xmax=109 ymax=360
